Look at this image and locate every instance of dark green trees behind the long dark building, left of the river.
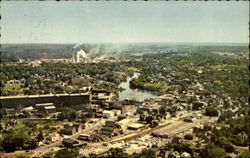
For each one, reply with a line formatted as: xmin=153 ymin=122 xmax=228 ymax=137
xmin=0 ymin=63 xmax=132 ymax=95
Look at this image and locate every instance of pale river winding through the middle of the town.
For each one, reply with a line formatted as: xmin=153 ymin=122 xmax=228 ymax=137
xmin=119 ymin=73 xmax=154 ymax=101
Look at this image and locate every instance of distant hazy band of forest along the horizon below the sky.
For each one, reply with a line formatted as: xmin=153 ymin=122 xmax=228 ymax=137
xmin=0 ymin=43 xmax=248 ymax=62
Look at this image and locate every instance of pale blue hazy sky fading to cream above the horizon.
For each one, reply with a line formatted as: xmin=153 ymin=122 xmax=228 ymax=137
xmin=1 ymin=1 xmax=249 ymax=43
